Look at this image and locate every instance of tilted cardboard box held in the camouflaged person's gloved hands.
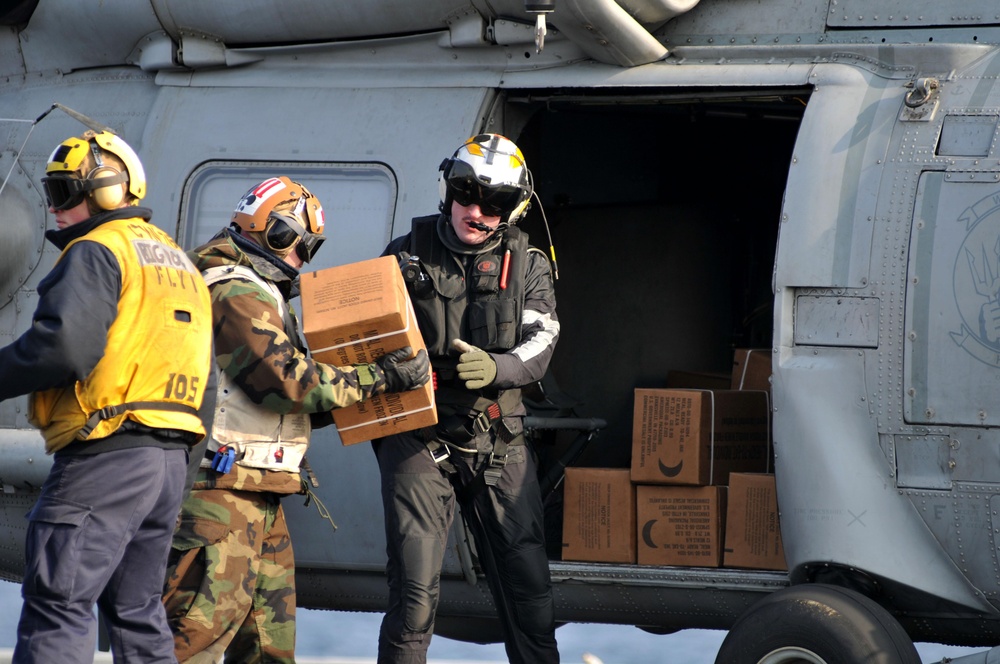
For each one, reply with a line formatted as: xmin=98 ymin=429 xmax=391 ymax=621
xmin=300 ymin=256 xmax=437 ymax=445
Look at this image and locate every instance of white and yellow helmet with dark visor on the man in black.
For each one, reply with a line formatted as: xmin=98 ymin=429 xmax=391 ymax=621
xmin=438 ymin=134 xmax=533 ymax=224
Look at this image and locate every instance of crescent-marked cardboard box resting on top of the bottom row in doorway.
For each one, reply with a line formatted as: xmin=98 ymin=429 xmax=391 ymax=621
xmin=632 ymin=389 xmax=770 ymax=485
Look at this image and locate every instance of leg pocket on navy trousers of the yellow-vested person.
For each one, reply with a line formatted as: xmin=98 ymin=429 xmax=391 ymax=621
xmin=24 ymin=495 xmax=91 ymax=600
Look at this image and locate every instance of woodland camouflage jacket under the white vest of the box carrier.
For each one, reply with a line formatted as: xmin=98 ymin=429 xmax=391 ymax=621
xmin=189 ymin=230 xmax=385 ymax=493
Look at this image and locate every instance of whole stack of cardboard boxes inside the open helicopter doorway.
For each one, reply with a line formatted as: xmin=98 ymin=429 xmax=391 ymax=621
xmin=563 ymin=350 xmax=785 ymax=569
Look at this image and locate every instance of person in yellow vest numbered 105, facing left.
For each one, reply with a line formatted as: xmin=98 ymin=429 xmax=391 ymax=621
xmin=0 ymin=131 xmax=215 ymax=664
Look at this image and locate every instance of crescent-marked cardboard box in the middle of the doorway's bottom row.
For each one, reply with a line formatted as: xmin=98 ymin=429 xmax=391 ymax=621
xmin=636 ymin=485 xmax=726 ymax=567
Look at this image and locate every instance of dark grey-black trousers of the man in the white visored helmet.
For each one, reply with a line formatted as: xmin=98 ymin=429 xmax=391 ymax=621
xmin=374 ymin=434 xmax=559 ymax=664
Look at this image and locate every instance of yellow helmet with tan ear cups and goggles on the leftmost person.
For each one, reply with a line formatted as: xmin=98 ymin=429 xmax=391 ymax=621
xmin=42 ymin=130 xmax=146 ymax=214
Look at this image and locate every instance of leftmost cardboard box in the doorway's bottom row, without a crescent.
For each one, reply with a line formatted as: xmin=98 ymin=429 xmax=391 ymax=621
xmin=562 ymin=468 xmax=635 ymax=563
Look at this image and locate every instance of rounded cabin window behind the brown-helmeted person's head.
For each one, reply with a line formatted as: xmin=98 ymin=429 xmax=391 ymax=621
xmin=177 ymin=161 xmax=396 ymax=270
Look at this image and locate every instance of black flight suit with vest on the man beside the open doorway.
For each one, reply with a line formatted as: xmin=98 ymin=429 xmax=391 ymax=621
xmin=374 ymin=215 xmax=559 ymax=664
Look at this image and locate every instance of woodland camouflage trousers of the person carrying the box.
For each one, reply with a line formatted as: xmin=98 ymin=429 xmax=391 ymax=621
xmin=163 ymin=489 xmax=295 ymax=664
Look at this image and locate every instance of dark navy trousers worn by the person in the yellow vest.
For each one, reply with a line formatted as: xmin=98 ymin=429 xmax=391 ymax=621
xmin=13 ymin=447 xmax=187 ymax=664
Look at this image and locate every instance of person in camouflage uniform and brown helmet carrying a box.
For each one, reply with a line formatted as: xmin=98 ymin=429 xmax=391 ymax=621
xmin=163 ymin=177 xmax=430 ymax=663
